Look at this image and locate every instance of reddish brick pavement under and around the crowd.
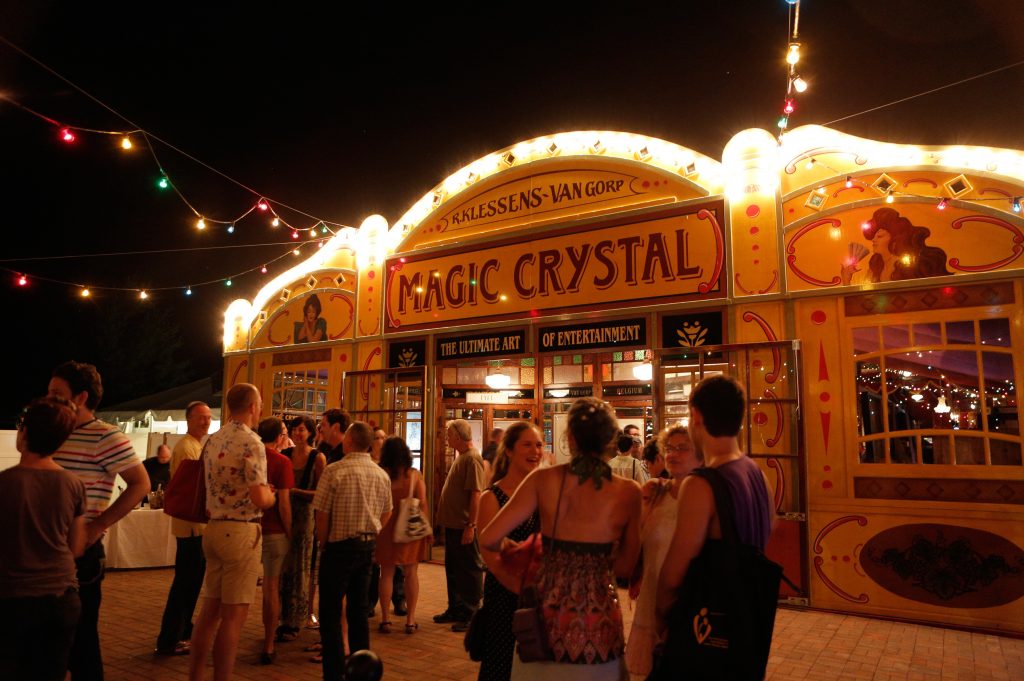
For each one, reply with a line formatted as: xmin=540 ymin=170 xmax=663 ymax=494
xmin=99 ymin=563 xmax=1024 ymax=681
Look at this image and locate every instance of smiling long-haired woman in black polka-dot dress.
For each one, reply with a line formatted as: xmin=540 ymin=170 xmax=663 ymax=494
xmin=477 ymin=421 xmax=544 ymax=681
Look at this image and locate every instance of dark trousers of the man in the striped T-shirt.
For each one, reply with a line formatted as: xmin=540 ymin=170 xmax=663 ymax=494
xmin=68 ymin=541 xmax=106 ymax=681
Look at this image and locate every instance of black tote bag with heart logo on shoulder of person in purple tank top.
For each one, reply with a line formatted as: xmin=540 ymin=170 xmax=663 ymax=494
xmin=647 ymin=468 xmax=783 ymax=681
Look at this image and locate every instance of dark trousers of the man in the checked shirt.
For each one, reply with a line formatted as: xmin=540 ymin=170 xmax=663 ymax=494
xmin=319 ymin=539 xmax=377 ymax=681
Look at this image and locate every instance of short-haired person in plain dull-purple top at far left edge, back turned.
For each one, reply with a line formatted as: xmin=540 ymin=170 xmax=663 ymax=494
xmin=0 ymin=397 xmax=85 ymax=681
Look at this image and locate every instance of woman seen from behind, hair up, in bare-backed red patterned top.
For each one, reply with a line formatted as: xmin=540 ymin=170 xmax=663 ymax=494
xmin=480 ymin=397 xmax=640 ymax=681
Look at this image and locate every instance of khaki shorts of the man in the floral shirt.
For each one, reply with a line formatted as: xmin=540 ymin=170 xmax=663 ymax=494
xmin=203 ymin=520 xmax=262 ymax=605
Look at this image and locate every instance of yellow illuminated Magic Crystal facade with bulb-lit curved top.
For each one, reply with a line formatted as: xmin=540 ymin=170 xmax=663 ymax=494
xmin=224 ymin=126 xmax=1024 ymax=634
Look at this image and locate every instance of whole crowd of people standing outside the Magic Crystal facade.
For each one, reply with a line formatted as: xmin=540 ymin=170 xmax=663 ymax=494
xmin=0 ymin=363 xmax=773 ymax=681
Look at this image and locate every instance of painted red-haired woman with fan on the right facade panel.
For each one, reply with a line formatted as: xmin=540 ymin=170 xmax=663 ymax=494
xmin=840 ymin=208 xmax=952 ymax=285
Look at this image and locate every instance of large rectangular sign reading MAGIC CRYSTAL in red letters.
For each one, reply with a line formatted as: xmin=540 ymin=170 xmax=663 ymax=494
xmin=386 ymin=203 xmax=725 ymax=330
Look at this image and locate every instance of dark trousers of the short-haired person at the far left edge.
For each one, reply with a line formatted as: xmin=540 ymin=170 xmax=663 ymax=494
xmin=0 ymin=589 xmax=82 ymax=681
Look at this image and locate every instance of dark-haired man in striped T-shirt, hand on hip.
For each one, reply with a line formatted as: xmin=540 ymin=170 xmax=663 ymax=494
xmin=48 ymin=361 xmax=150 ymax=681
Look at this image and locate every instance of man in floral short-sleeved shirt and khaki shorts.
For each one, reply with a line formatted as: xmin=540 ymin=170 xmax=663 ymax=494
xmin=188 ymin=383 xmax=275 ymax=681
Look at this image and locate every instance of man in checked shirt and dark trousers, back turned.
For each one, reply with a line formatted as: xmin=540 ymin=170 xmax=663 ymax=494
xmin=313 ymin=421 xmax=391 ymax=681
